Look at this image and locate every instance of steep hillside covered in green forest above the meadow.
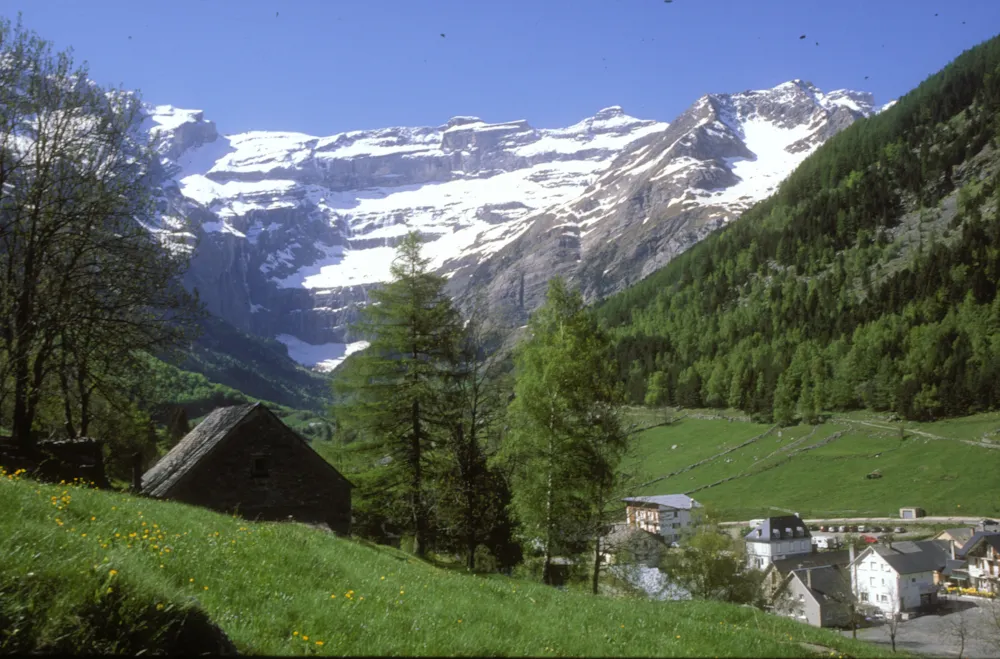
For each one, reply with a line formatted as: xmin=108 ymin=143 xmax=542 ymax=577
xmin=597 ymin=33 xmax=1000 ymax=422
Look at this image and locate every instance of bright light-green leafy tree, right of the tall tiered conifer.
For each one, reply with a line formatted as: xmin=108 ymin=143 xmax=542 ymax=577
xmin=497 ymin=277 xmax=627 ymax=584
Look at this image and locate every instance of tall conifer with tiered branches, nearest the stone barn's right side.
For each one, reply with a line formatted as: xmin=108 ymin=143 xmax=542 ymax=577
xmin=333 ymin=232 xmax=463 ymax=556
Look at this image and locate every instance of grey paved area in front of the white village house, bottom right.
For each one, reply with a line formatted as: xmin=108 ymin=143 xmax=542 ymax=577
xmin=843 ymin=598 xmax=1000 ymax=659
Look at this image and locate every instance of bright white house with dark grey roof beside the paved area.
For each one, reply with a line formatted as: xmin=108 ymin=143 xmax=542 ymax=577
xmin=851 ymin=540 xmax=952 ymax=616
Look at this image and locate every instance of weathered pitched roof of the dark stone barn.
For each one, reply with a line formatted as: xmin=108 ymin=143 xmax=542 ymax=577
xmin=142 ymin=403 xmax=353 ymax=497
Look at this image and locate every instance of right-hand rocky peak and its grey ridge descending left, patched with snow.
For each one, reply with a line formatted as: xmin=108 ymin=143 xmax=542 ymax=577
xmin=450 ymin=80 xmax=876 ymax=324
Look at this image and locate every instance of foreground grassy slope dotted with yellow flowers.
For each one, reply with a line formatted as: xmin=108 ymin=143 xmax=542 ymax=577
xmin=0 ymin=478 xmax=888 ymax=657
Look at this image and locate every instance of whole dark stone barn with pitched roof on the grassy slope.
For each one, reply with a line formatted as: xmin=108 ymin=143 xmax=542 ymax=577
xmin=141 ymin=403 xmax=354 ymax=534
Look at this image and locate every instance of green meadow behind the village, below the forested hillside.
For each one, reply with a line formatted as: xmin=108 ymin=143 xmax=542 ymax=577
xmin=637 ymin=412 xmax=1000 ymax=519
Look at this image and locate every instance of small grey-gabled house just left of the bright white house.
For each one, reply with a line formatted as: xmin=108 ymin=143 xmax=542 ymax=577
xmin=774 ymin=565 xmax=853 ymax=627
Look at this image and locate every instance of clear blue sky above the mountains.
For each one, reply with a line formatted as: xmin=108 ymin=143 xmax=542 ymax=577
xmin=0 ymin=0 xmax=1000 ymax=135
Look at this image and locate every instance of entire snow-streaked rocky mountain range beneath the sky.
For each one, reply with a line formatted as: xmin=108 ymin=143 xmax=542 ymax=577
xmin=147 ymin=80 xmax=874 ymax=368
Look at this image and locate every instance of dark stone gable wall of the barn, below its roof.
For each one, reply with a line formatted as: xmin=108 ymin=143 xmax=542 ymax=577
xmin=168 ymin=415 xmax=351 ymax=534
